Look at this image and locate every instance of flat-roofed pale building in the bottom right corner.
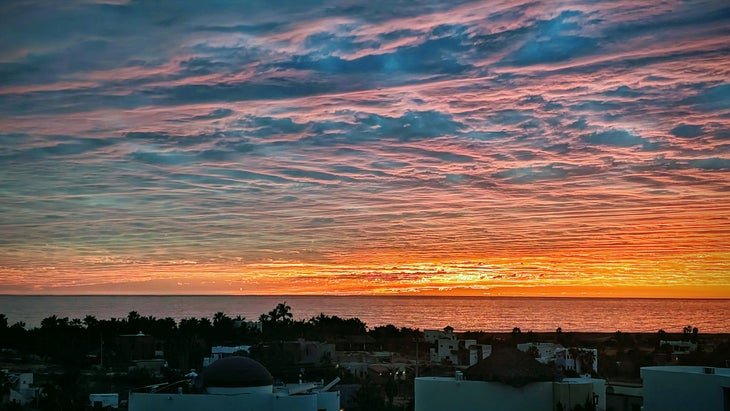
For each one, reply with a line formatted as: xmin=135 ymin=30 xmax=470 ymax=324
xmin=641 ymin=366 xmax=730 ymax=411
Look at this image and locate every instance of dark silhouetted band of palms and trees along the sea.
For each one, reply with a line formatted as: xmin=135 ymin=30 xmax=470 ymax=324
xmin=0 ymin=303 xmax=422 ymax=369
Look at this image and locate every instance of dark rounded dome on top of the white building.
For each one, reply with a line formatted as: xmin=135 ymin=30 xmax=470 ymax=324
xmin=200 ymin=357 xmax=274 ymax=387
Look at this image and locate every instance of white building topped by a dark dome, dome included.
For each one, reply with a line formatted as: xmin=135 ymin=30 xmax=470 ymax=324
xmin=129 ymin=356 xmax=340 ymax=411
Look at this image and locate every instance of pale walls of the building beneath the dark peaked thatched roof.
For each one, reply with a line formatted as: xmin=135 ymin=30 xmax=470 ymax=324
xmin=415 ymin=377 xmax=606 ymax=411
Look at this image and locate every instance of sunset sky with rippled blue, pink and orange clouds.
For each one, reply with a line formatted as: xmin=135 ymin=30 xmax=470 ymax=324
xmin=0 ymin=0 xmax=730 ymax=298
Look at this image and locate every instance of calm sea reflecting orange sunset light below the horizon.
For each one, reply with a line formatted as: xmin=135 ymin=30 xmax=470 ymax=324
xmin=0 ymin=296 xmax=730 ymax=333
